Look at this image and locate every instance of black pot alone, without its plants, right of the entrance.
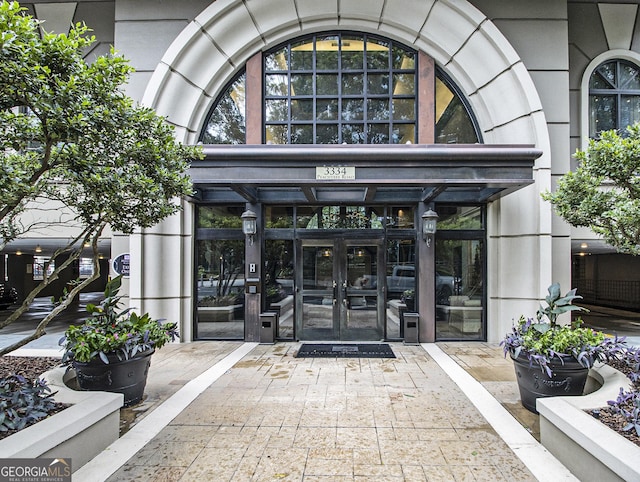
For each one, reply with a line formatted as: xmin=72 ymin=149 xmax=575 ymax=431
xmin=511 ymin=353 xmax=589 ymax=413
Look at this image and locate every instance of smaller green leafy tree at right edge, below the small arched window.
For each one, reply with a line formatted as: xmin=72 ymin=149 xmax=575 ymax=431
xmin=543 ymin=123 xmax=640 ymax=255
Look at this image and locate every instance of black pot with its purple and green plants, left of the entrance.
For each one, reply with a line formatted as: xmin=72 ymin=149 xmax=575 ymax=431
xmin=59 ymin=275 xmax=178 ymax=406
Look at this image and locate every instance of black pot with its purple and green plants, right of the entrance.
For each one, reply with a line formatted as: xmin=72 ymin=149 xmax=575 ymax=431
xmin=501 ymin=283 xmax=626 ymax=413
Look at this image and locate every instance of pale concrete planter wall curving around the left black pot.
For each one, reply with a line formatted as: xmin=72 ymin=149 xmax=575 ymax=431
xmin=0 ymin=368 xmax=124 ymax=471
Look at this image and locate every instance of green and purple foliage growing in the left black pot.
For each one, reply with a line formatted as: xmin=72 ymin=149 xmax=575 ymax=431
xmin=60 ymin=276 xmax=177 ymax=363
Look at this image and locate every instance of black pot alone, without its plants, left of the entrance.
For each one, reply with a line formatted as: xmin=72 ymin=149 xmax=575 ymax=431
xmin=73 ymin=350 xmax=155 ymax=407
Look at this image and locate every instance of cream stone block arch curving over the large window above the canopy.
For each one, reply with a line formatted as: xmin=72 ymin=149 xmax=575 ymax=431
xmin=143 ymin=0 xmax=548 ymax=149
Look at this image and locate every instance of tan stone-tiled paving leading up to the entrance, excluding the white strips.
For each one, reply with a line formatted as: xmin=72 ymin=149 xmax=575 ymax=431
xmin=108 ymin=342 xmax=536 ymax=482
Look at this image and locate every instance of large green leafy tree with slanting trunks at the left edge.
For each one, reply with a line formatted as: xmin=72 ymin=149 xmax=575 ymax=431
xmin=0 ymin=1 xmax=201 ymax=354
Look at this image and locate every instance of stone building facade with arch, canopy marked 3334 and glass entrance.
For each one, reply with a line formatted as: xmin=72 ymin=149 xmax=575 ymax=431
xmin=7 ymin=0 xmax=640 ymax=342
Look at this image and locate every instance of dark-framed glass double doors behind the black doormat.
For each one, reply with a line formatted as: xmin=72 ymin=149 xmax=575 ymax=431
xmin=296 ymin=239 xmax=384 ymax=341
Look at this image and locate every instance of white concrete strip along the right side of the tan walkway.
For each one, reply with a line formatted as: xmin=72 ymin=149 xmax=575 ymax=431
xmin=422 ymin=343 xmax=578 ymax=481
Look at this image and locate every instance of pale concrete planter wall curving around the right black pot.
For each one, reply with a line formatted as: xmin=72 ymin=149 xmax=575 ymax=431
xmin=536 ymin=365 xmax=640 ymax=482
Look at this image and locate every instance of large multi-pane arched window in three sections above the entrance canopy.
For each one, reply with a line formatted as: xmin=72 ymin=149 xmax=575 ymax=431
xmin=200 ymin=33 xmax=481 ymax=144
